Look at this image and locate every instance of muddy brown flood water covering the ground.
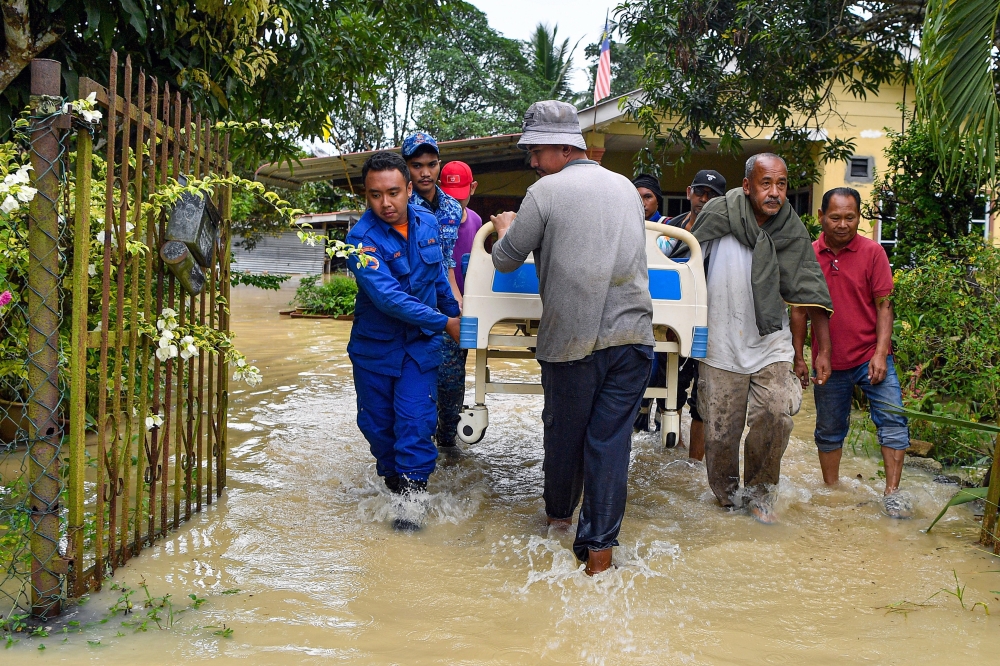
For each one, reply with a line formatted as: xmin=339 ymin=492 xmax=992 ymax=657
xmin=9 ymin=278 xmax=1000 ymax=664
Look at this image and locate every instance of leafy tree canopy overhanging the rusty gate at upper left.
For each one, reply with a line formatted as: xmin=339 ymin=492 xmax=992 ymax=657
xmin=0 ymin=0 xmax=454 ymax=167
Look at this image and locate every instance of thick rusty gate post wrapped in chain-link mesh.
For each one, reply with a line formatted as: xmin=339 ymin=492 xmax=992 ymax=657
xmin=28 ymin=59 xmax=65 ymax=618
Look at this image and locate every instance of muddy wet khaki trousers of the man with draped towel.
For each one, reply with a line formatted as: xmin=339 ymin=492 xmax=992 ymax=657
xmin=698 ymin=361 xmax=802 ymax=506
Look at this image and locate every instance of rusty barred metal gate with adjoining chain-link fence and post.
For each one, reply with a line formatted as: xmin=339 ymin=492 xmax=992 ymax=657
xmin=0 ymin=54 xmax=232 ymax=619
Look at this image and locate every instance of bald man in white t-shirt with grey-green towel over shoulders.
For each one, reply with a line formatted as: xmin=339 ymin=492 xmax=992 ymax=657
xmin=694 ymin=153 xmax=832 ymax=523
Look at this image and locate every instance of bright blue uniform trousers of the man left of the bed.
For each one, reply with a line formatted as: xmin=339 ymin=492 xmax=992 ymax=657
xmin=354 ymin=355 xmax=437 ymax=481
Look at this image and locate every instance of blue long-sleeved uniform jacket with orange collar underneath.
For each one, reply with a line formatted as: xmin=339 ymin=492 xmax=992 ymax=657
xmin=347 ymin=206 xmax=460 ymax=377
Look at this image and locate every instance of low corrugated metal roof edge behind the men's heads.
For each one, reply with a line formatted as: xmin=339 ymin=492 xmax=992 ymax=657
xmin=256 ymin=134 xmax=530 ymax=189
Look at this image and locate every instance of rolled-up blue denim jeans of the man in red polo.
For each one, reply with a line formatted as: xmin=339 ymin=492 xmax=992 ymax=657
xmin=813 ymin=356 xmax=910 ymax=453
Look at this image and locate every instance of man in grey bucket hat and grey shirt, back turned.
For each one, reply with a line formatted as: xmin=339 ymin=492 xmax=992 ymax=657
xmin=491 ymin=100 xmax=653 ymax=575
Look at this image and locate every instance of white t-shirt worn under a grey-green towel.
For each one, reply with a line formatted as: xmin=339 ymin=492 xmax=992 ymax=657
xmin=703 ymin=234 xmax=795 ymax=375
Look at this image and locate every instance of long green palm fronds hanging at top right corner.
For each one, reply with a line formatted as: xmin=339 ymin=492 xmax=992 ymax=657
xmin=916 ymin=0 xmax=1000 ymax=184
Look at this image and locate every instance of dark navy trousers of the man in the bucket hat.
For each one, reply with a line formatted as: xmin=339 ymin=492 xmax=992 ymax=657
xmin=540 ymin=345 xmax=653 ymax=560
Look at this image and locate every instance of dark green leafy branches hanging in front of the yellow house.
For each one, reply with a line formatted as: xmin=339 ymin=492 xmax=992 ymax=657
xmin=616 ymin=0 xmax=923 ymax=185
